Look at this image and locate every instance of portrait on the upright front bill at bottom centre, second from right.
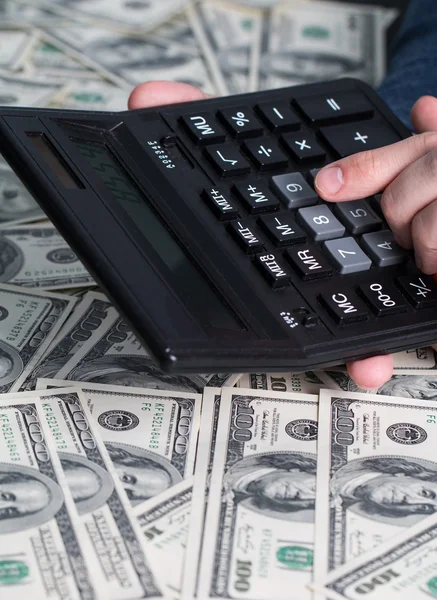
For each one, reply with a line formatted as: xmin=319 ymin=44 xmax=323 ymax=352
xmin=224 ymin=452 xmax=317 ymax=522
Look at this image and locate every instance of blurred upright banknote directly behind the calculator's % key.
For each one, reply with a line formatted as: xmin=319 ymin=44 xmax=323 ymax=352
xmin=188 ymin=0 xmax=262 ymax=94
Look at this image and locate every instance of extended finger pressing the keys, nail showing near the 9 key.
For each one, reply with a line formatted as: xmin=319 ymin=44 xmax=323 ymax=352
xmin=315 ymin=132 xmax=437 ymax=202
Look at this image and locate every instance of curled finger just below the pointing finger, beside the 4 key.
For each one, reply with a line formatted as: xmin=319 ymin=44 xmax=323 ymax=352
xmin=381 ymin=148 xmax=437 ymax=248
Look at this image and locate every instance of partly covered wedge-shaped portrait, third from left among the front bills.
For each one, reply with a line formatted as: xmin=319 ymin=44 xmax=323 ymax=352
xmin=105 ymin=442 xmax=182 ymax=506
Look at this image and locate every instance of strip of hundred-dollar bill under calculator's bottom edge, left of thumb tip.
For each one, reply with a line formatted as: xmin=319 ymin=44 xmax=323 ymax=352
xmin=236 ymin=371 xmax=324 ymax=394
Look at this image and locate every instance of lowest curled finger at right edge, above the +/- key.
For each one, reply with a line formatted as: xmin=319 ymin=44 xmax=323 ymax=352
xmin=411 ymin=197 xmax=437 ymax=275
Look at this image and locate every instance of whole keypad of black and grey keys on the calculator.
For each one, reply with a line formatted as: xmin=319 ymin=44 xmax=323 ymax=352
xmin=184 ymin=92 xmax=422 ymax=326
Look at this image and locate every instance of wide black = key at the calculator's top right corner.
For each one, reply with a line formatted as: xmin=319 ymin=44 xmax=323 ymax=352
xmin=296 ymin=92 xmax=373 ymax=125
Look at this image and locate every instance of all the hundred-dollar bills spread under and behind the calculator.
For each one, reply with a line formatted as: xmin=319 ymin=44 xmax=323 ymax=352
xmin=0 ymin=0 xmax=437 ymax=600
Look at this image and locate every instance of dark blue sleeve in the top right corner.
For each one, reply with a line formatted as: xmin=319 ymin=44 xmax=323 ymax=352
xmin=378 ymin=0 xmax=437 ymax=129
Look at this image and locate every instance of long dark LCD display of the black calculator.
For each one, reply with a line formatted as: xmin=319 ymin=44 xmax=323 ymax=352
xmin=71 ymin=138 xmax=246 ymax=331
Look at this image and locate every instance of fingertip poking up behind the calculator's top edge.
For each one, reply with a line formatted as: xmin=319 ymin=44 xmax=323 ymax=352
xmin=128 ymin=81 xmax=209 ymax=109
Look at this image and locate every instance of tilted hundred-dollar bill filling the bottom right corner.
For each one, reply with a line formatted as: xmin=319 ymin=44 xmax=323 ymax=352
xmin=314 ymin=515 xmax=437 ymax=600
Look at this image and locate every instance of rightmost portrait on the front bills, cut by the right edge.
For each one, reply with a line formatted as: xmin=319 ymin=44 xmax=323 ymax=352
xmin=331 ymin=456 xmax=437 ymax=526
